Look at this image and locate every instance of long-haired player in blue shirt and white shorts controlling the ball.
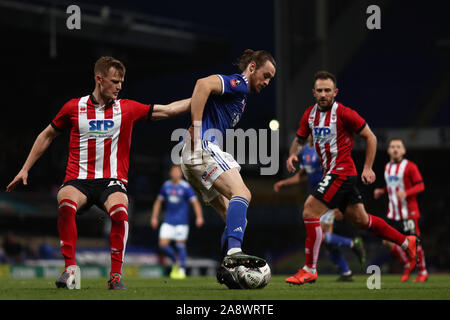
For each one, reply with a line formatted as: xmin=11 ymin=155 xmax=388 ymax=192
xmin=181 ymin=49 xmax=276 ymax=286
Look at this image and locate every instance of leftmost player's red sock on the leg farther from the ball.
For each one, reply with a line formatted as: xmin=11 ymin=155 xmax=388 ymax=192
xmin=58 ymin=199 xmax=77 ymax=267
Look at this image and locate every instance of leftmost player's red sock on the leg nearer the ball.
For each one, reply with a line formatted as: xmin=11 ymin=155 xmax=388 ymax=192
xmin=109 ymin=204 xmax=128 ymax=274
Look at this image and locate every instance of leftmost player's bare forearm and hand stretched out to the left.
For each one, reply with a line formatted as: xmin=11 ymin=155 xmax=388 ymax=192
xmin=6 ymin=125 xmax=59 ymax=192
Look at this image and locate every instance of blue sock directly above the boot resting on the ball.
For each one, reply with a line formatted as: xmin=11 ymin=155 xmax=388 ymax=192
xmin=226 ymin=196 xmax=248 ymax=250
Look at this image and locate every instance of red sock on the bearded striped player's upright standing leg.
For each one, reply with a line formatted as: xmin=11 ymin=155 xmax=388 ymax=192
xmin=303 ymin=219 xmax=322 ymax=269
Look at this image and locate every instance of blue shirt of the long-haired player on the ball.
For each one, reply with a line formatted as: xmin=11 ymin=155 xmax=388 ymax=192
xmin=202 ymin=73 xmax=249 ymax=142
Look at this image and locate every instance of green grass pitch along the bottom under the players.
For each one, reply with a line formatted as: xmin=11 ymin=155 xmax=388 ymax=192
xmin=0 ymin=274 xmax=450 ymax=300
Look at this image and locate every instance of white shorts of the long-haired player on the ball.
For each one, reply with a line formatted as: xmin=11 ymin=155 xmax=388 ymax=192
xmin=181 ymin=141 xmax=241 ymax=203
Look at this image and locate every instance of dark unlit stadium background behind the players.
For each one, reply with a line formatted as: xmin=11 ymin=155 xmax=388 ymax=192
xmin=0 ymin=0 xmax=450 ymax=272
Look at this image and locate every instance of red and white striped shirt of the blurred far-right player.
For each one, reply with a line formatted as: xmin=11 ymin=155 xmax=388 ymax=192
xmin=384 ymin=159 xmax=425 ymax=220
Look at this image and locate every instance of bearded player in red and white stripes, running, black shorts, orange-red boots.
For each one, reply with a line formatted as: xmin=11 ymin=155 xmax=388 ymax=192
xmin=286 ymin=71 xmax=416 ymax=284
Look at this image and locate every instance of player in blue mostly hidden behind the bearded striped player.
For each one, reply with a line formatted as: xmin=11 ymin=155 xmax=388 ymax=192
xmin=273 ymin=136 xmax=366 ymax=281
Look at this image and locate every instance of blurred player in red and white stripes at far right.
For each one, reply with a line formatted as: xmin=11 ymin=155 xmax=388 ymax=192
xmin=374 ymin=138 xmax=428 ymax=282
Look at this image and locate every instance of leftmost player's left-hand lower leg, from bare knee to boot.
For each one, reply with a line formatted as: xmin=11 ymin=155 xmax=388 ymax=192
xmin=55 ymin=185 xmax=87 ymax=289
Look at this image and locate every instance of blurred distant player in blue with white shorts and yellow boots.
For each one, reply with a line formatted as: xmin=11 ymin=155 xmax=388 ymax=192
xmin=150 ymin=165 xmax=203 ymax=279
